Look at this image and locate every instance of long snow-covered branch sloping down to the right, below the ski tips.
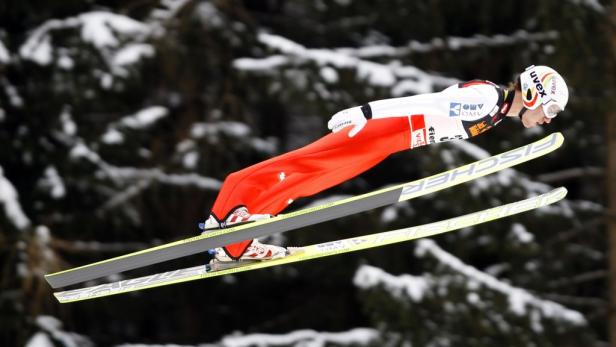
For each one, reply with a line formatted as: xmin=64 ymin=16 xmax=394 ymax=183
xmin=415 ymin=239 xmax=586 ymax=325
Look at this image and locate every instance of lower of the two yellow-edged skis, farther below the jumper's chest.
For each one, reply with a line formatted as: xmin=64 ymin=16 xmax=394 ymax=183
xmin=54 ymin=187 xmax=567 ymax=303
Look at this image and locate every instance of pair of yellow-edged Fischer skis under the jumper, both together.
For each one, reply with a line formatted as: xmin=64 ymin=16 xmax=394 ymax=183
xmin=45 ymin=133 xmax=567 ymax=303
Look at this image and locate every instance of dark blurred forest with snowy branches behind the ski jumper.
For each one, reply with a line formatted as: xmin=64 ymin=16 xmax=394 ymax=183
xmin=0 ymin=0 xmax=616 ymax=347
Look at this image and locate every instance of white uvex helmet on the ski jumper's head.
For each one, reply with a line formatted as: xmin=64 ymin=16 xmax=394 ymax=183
xmin=520 ymin=65 xmax=569 ymax=118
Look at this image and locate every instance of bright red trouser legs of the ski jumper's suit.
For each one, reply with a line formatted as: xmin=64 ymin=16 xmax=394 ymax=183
xmin=212 ymin=117 xmax=410 ymax=257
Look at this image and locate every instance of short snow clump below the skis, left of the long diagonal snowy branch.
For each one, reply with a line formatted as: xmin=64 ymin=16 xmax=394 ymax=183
xmin=353 ymin=265 xmax=430 ymax=302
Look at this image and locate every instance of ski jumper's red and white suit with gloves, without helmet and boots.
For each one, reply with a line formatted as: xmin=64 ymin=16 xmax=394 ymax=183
xmin=211 ymin=80 xmax=514 ymax=259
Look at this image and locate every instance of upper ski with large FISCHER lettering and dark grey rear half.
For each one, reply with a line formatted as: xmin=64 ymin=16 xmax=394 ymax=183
xmin=45 ymin=132 xmax=564 ymax=288
